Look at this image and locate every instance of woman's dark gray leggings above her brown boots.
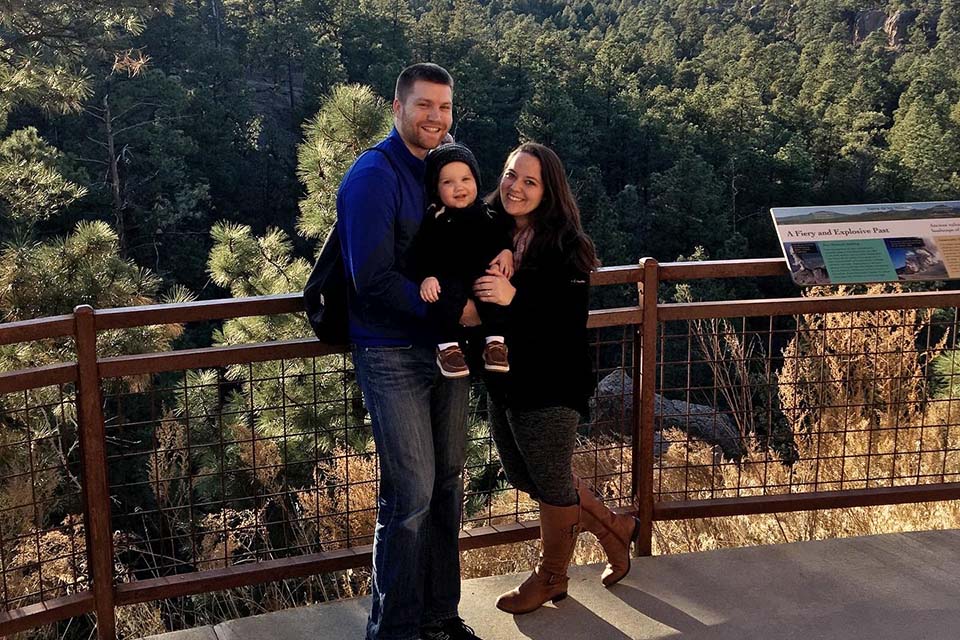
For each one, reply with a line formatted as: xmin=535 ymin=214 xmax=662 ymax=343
xmin=489 ymin=398 xmax=580 ymax=507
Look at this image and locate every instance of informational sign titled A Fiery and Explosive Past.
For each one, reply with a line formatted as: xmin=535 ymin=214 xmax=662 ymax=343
xmin=770 ymin=201 xmax=960 ymax=285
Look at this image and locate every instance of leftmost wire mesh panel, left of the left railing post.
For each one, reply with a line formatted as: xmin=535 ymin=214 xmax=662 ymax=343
xmin=0 ymin=384 xmax=89 ymax=611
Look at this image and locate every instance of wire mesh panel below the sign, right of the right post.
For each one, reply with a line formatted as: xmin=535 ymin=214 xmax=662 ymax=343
xmin=654 ymin=300 xmax=960 ymax=501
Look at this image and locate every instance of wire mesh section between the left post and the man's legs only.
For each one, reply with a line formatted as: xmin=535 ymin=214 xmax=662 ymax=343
xmin=106 ymin=354 xmax=364 ymax=579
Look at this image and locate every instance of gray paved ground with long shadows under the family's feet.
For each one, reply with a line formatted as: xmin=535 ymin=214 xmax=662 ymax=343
xmin=141 ymin=531 xmax=960 ymax=640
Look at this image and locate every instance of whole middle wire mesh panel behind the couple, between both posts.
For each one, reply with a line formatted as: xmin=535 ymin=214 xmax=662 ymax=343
xmin=105 ymin=327 xmax=633 ymax=582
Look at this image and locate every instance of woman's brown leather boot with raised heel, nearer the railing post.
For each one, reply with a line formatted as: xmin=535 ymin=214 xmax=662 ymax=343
xmin=573 ymin=475 xmax=640 ymax=587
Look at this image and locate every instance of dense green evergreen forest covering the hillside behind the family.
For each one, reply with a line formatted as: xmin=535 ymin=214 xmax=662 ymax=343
xmin=0 ymin=0 xmax=960 ymax=638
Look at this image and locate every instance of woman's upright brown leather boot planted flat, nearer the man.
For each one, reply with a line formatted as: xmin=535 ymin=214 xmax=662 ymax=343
xmin=497 ymin=502 xmax=580 ymax=614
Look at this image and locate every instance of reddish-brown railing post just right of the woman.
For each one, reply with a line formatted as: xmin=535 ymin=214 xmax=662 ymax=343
xmin=633 ymin=258 xmax=660 ymax=556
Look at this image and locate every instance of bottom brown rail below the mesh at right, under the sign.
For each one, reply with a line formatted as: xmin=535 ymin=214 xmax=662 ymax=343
xmin=653 ymin=482 xmax=960 ymax=520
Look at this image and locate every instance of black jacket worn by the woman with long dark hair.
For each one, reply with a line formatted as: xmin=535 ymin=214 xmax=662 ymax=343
xmin=486 ymin=238 xmax=596 ymax=416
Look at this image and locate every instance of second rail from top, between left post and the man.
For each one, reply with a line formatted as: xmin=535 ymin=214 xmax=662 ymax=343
xmin=100 ymin=338 xmax=346 ymax=378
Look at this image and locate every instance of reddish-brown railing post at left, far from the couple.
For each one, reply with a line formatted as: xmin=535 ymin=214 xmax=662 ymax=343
xmin=74 ymin=305 xmax=117 ymax=640
